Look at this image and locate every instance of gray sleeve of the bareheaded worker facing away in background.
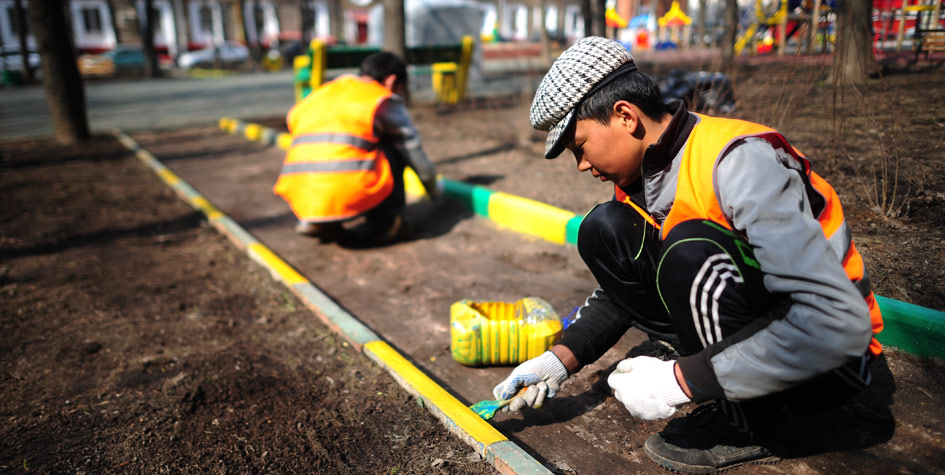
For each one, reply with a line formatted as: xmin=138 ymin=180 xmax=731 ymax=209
xmin=374 ymin=94 xmax=436 ymax=185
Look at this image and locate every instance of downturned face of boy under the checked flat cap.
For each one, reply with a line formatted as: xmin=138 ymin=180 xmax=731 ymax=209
xmin=568 ymin=105 xmax=644 ymax=187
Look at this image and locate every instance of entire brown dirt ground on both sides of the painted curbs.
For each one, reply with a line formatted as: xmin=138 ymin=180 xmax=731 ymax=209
xmin=0 ymin=54 xmax=945 ymax=474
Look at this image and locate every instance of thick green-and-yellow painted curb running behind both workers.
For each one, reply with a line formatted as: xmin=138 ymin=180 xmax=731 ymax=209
xmin=219 ymin=117 xmax=945 ymax=359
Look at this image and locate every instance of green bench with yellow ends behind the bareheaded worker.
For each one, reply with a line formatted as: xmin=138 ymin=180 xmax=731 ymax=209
xmin=293 ymin=36 xmax=473 ymax=104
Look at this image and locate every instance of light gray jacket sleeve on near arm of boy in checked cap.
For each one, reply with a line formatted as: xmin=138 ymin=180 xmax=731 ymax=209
xmin=710 ymin=139 xmax=872 ymax=401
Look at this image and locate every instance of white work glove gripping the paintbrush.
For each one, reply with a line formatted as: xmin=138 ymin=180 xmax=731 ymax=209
xmin=492 ymin=351 xmax=568 ymax=412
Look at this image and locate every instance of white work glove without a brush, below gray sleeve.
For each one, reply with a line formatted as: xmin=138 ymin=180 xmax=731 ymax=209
xmin=607 ymin=356 xmax=691 ymax=421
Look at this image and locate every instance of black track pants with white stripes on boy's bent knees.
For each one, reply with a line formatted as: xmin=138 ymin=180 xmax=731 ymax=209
xmin=578 ymin=201 xmax=772 ymax=355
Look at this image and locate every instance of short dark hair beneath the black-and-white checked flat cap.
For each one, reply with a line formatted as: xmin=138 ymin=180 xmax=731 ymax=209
xmin=575 ymin=71 xmax=669 ymax=125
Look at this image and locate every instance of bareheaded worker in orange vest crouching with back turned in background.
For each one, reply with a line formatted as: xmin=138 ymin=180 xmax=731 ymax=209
xmin=273 ymin=52 xmax=437 ymax=242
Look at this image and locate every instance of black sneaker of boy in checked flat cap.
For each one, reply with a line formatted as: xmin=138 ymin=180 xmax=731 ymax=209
xmin=644 ymin=403 xmax=784 ymax=473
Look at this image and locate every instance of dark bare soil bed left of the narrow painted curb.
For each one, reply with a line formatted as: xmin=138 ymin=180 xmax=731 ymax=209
xmin=0 ymin=137 xmax=494 ymax=474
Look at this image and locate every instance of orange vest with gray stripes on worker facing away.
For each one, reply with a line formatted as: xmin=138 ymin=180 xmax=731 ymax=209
xmin=273 ymin=75 xmax=394 ymax=222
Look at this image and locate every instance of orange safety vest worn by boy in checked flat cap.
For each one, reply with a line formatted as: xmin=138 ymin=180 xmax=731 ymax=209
xmin=616 ymin=114 xmax=883 ymax=356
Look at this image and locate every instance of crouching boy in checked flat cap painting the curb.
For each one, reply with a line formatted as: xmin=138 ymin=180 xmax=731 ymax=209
xmin=493 ymin=37 xmax=882 ymax=472
